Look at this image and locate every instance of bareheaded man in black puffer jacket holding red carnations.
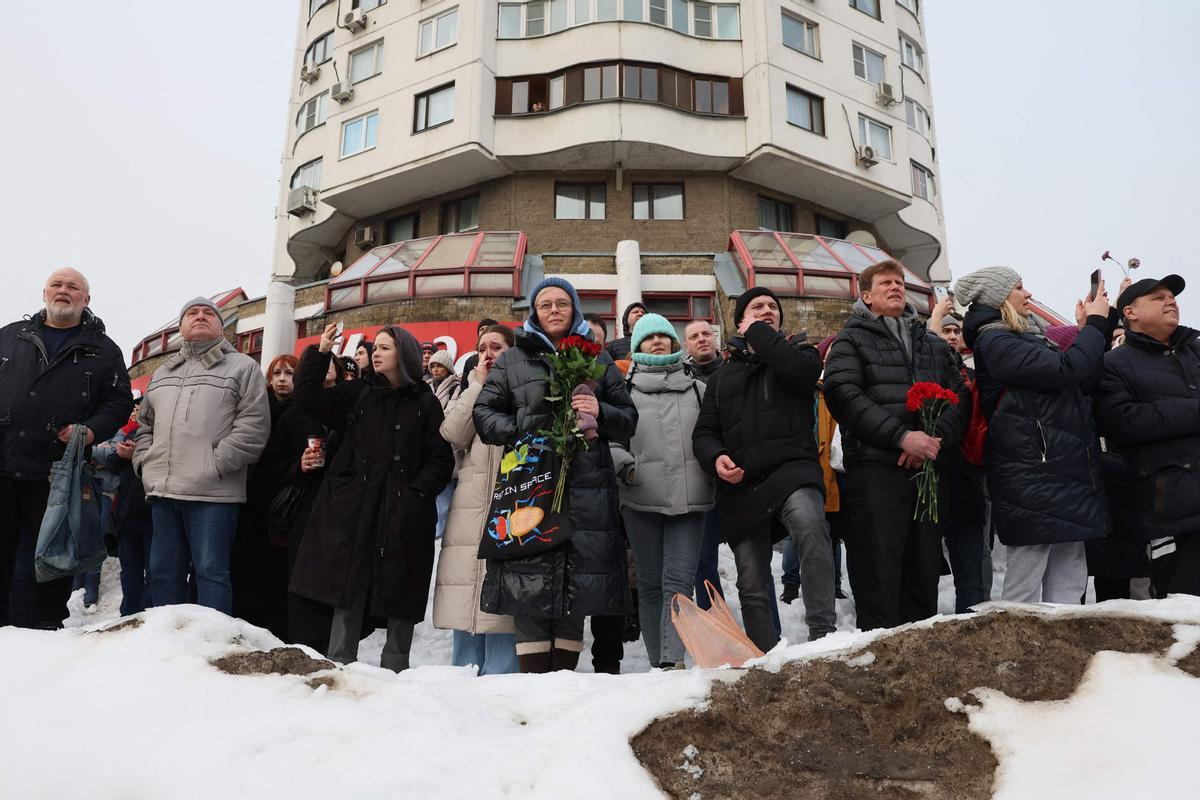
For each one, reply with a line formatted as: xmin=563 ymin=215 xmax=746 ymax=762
xmin=824 ymin=260 xmax=971 ymax=631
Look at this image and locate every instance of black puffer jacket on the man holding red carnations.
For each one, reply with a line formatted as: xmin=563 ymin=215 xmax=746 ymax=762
xmin=824 ymin=300 xmax=971 ymax=469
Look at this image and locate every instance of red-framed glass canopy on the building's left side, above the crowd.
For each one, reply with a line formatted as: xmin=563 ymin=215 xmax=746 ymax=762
xmin=325 ymin=230 xmax=526 ymax=309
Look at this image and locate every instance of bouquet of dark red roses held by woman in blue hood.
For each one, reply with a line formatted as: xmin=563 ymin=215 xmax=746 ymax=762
xmin=540 ymin=336 xmax=607 ymax=513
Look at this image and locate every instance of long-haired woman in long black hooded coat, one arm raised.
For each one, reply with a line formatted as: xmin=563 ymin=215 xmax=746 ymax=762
xmin=292 ymin=325 xmax=454 ymax=672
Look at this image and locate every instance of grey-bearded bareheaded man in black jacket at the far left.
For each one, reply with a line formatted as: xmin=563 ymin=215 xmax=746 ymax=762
xmin=0 ymin=267 xmax=133 ymax=628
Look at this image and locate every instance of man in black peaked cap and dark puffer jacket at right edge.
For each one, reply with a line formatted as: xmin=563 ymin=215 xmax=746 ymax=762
xmin=1096 ymin=275 xmax=1200 ymax=597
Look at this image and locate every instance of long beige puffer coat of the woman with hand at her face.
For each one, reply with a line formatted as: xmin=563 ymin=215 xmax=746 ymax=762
xmin=433 ymin=375 xmax=512 ymax=633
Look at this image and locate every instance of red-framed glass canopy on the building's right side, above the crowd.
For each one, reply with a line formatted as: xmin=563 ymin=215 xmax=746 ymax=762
xmin=730 ymin=230 xmax=934 ymax=314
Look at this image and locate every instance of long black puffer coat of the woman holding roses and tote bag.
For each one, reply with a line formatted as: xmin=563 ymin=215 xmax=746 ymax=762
xmin=473 ymin=332 xmax=637 ymax=619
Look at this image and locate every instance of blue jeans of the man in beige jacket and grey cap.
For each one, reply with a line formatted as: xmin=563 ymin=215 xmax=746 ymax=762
xmin=150 ymin=498 xmax=241 ymax=614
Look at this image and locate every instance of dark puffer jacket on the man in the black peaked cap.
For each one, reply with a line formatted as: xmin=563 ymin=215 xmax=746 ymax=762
xmin=1096 ymin=326 xmax=1200 ymax=539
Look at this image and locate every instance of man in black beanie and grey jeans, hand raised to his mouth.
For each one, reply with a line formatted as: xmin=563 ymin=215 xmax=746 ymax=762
xmin=692 ymin=287 xmax=836 ymax=651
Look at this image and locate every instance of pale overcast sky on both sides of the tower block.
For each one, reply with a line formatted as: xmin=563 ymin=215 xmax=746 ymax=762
xmin=0 ymin=0 xmax=1200 ymax=357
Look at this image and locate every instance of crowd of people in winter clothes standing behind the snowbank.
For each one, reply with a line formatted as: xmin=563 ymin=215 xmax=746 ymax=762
xmin=0 ymin=261 xmax=1200 ymax=674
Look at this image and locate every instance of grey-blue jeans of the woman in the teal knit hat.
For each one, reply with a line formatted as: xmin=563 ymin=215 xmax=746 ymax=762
xmin=620 ymin=509 xmax=704 ymax=667
